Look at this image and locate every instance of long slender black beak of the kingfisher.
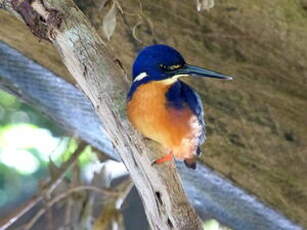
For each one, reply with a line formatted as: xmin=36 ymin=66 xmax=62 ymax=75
xmin=175 ymin=64 xmax=232 ymax=80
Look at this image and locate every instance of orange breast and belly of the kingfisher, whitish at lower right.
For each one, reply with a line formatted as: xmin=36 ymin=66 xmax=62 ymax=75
xmin=127 ymin=82 xmax=201 ymax=159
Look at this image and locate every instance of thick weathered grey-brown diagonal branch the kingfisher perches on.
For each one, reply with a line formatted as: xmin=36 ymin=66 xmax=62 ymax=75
xmin=0 ymin=0 xmax=202 ymax=230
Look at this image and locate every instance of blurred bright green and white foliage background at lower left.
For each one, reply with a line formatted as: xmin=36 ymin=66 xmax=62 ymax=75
xmin=0 ymin=91 xmax=96 ymax=210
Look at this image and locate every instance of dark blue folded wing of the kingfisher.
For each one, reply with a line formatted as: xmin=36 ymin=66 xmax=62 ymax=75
xmin=166 ymin=80 xmax=206 ymax=154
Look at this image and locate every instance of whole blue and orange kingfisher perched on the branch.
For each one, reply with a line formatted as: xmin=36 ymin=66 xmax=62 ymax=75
xmin=127 ymin=45 xmax=232 ymax=169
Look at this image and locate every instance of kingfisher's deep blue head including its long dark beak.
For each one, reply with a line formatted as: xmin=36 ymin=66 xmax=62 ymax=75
xmin=128 ymin=45 xmax=231 ymax=98
